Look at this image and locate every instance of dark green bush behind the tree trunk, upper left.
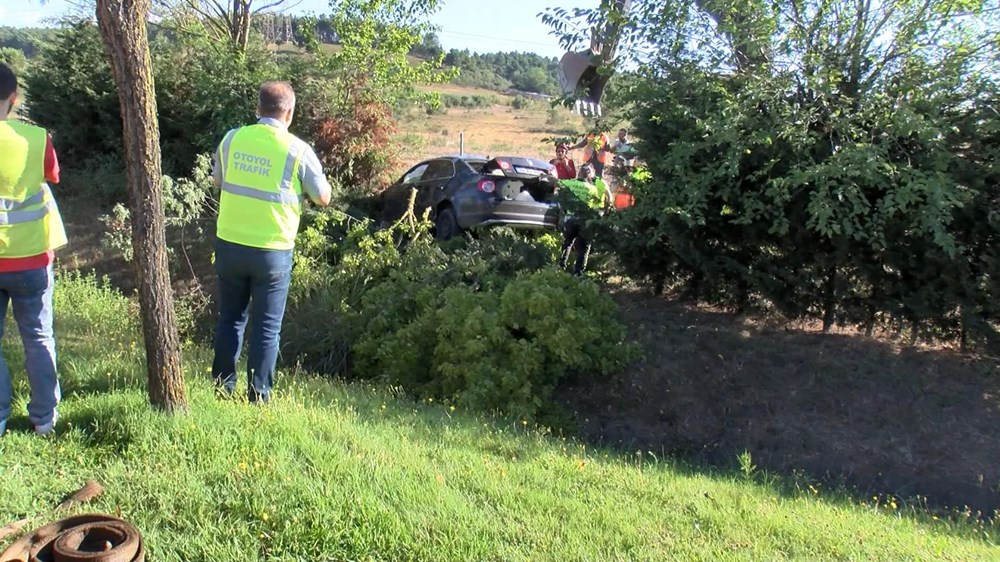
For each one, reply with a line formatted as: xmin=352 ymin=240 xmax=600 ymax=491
xmin=26 ymin=22 xmax=277 ymax=204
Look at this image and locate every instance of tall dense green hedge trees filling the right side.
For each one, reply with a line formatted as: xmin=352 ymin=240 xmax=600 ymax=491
xmin=557 ymin=0 xmax=1000 ymax=349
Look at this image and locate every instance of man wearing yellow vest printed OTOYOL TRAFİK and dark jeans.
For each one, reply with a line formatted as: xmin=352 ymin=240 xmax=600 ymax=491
xmin=212 ymin=82 xmax=331 ymax=403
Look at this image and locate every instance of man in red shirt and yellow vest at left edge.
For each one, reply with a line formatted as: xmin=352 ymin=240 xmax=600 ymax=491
xmin=0 ymin=63 xmax=66 ymax=435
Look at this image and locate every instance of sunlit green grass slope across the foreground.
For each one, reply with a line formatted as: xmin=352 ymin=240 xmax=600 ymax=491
xmin=0 ymin=277 xmax=1000 ymax=561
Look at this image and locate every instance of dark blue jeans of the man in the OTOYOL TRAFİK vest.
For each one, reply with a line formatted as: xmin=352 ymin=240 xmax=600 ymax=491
xmin=212 ymin=240 xmax=292 ymax=402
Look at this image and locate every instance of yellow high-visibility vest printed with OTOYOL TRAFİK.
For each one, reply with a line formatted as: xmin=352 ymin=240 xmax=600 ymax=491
xmin=216 ymin=124 xmax=308 ymax=250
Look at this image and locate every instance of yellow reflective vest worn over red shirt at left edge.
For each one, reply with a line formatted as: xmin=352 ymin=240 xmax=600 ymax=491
xmin=0 ymin=121 xmax=66 ymax=258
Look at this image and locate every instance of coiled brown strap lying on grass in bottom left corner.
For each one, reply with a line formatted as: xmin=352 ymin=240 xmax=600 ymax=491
xmin=0 ymin=513 xmax=145 ymax=562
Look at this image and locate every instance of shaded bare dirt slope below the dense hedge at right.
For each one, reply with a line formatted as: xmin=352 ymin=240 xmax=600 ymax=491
xmin=560 ymin=291 xmax=1000 ymax=514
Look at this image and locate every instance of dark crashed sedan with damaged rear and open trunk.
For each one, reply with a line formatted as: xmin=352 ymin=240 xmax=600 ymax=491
xmin=381 ymin=155 xmax=560 ymax=240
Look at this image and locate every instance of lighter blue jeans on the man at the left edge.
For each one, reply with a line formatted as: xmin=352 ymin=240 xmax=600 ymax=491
xmin=0 ymin=265 xmax=62 ymax=433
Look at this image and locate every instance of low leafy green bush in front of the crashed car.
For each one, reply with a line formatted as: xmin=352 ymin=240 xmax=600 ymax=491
xmin=282 ymin=208 xmax=634 ymax=419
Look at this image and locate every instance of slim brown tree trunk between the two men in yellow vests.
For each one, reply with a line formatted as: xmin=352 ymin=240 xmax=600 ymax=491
xmin=97 ymin=0 xmax=187 ymax=413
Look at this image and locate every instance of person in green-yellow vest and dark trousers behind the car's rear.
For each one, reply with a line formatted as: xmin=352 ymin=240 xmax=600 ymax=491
xmin=556 ymin=164 xmax=609 ymax=275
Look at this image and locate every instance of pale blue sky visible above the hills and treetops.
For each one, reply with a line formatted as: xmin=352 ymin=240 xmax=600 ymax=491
xmin=0 ymin=0 xmax=588 ymax=58
